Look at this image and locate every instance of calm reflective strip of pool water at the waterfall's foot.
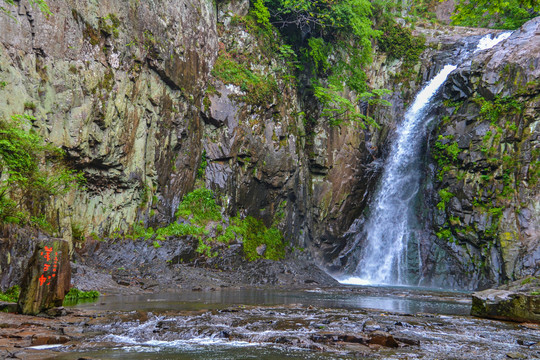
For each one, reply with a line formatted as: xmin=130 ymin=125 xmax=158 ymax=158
xmin=74 ymin=289 xmax=470 ymax=315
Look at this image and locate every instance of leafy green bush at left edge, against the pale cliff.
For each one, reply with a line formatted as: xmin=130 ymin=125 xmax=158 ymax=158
xmin=0 ymin=115 xmax=84 ymax=231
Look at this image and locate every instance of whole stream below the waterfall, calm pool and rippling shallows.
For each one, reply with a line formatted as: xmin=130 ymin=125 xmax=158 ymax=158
xmin=41 ymin=286 xmax=540 ymax=360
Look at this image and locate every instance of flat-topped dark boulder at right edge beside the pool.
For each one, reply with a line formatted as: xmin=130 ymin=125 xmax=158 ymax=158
xmin=471 ymin=289 xmax=540 ymax=323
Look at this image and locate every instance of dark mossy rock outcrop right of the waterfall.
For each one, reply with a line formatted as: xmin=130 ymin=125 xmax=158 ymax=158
xmin=424 ymin=18 xmax=540 ymax=288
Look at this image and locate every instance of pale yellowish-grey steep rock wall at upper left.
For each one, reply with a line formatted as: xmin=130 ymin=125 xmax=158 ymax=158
xmin=0 ymin=0 xmax=218 ymax=238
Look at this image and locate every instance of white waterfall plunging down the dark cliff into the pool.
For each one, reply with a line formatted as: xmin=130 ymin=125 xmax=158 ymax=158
xmin=340 ymin=33 xmax=510 ymax=285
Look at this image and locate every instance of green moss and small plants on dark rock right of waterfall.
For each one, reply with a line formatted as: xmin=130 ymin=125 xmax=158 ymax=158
xmin=432 ymin=91 xmax=540 ymax=253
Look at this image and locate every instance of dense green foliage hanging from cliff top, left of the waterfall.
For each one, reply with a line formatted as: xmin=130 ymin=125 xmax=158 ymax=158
xmin=251 ymin=0 xmax=386 ymax=126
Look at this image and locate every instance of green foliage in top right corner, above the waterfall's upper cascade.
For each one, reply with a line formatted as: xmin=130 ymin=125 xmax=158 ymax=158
xmin=452 ymin=0 xmax=540 ymax=30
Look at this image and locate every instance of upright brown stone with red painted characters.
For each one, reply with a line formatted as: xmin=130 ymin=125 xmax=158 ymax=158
xmin=18 ymin=239 xmax=71 ymax=315
